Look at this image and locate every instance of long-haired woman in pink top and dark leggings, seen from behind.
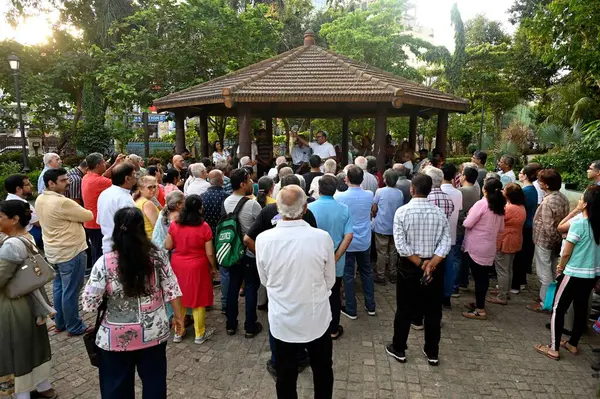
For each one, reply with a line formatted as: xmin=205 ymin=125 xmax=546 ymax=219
xmin=463 ymin=179 xmax=506 ymax=320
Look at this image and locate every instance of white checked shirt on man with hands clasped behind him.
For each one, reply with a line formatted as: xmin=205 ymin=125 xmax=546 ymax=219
xmin=394 ymin=198 xmax=451 ymax=258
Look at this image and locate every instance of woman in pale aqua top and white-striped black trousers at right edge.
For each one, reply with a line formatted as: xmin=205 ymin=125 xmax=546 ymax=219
xmin=535 ymin=185 xmax=600 ymax=360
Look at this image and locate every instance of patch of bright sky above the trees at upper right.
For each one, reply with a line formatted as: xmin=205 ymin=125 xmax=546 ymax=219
xmin=411 ymin=0 xmax=515 ymax=51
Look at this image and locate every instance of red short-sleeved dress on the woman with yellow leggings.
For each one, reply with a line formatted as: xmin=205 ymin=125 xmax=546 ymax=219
xmin=169 ymin=222 xmax=214 ymax=309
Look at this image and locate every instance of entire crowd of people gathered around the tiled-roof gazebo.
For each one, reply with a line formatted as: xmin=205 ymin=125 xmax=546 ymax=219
xmin=0 ymin=131 xmax=600 ymax=399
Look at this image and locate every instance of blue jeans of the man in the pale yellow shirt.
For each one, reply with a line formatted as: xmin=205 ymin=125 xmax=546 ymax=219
xmin=53 ymin=251 xmax=87 ymax=335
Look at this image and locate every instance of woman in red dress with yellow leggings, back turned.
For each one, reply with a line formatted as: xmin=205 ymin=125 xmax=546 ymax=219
xmin=165 ymin=194 xmax=217 ymax=344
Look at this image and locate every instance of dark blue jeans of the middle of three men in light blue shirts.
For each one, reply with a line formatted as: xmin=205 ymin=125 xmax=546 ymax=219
xmin=344 ymin=249 xmax=376 ymax=316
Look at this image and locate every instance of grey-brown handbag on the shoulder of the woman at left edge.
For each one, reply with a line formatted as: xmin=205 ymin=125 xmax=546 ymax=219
xmin=4 ymin=237 xmax=54 ymax=299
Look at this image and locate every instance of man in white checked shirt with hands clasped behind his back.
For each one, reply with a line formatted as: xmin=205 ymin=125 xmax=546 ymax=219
xmin=386 ymin=174 xmax=451 ymax=366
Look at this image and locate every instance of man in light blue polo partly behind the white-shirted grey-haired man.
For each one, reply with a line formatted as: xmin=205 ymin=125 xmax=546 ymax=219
xmin=308 ymin=176 xmax=353 ymax=339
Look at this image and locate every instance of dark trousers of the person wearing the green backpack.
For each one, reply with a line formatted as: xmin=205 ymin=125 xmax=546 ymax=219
xmin=221 ymin=256 xmax=260 ymax=333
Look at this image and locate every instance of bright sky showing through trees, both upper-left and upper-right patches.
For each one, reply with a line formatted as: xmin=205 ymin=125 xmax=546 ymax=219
xmin=0 ymin=0 xmax=514 ymax=51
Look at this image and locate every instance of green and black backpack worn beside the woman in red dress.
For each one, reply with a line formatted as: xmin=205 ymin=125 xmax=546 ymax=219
xmin=215 ymin=197 xmax=248 ymax=267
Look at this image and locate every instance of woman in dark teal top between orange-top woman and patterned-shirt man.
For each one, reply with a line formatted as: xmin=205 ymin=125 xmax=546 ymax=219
xmin=510 ymin=164 xmax=541 ymax=294
